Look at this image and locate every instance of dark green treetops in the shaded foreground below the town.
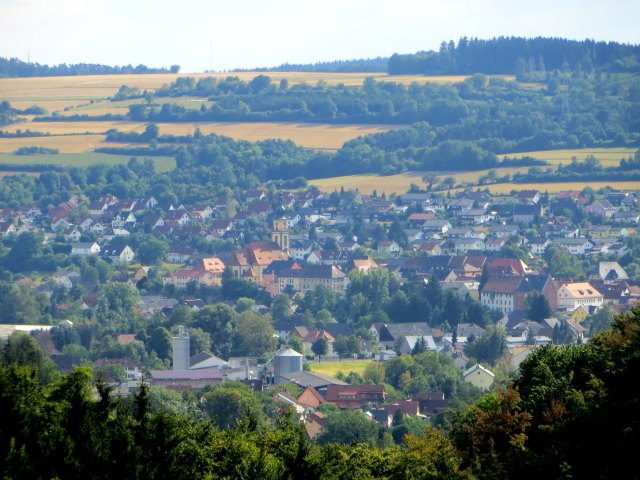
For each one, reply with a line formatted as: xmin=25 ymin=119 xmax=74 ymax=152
xmin=0 ymin=308 xmax=640 ymax=479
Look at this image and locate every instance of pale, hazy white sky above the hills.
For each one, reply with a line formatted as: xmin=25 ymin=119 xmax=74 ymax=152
xmin=0 ymin=0 xmax=640 ymax=73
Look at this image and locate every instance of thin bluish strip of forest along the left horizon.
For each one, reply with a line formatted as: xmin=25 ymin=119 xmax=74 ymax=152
xmin=0 ymin=57 xmax=180 ymax=78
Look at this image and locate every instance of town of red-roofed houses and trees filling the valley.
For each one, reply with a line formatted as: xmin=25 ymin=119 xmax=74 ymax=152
xmin=0 ymin=172 xmax=640 ymax=438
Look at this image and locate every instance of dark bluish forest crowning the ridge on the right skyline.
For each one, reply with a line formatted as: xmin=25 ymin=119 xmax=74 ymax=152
xmin=388 ymin=37 xmax=640 ymax=77
